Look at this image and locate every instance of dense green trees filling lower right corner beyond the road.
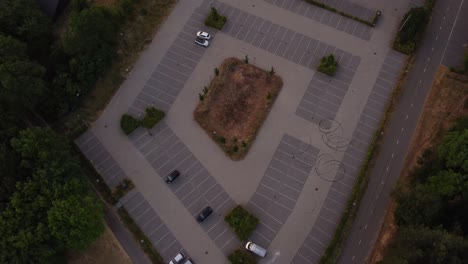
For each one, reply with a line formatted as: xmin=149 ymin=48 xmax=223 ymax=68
xmin=382 ymin=117 xmax=468 ymax=264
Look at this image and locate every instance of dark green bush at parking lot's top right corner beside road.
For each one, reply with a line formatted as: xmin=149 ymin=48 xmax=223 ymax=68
xmin=393 ymin=7 xmax=430 ymax=54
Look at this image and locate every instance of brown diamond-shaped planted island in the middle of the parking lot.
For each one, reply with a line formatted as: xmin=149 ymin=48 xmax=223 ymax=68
xmin=193 ymin=58 xmax=283 ymax=160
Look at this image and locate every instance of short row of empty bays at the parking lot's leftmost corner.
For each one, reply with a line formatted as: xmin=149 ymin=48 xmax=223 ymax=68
xmin=75 ymin=130 xmax=127 ymax=189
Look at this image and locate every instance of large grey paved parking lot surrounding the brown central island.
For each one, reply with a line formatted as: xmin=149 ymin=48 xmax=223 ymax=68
xmin=76 ymin=0 xmax=405 ymax=263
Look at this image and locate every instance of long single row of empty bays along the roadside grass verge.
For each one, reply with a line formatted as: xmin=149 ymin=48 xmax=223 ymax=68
xmin=292 ymin=50 xmax=406 ymax=264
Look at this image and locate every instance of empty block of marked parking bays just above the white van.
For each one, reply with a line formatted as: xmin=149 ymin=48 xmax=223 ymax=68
xmin=247 ymin=134 xmax=319 ymax=247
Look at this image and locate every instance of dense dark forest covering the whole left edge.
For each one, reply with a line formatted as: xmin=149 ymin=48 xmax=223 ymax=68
xmin=0 ymin=0 xmax=122 ymax=263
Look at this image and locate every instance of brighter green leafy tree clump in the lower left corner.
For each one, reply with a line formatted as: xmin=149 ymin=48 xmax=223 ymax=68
xmin=0 ymin=128 xmax=104 ymax=263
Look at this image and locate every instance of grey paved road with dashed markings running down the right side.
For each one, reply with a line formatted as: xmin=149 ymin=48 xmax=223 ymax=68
xmin=339 ymin=0 xmax=468 ymax=263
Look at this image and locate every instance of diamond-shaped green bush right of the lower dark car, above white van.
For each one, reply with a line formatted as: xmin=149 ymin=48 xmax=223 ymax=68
xmin=224 ymin=206 xmax=259 ymax=241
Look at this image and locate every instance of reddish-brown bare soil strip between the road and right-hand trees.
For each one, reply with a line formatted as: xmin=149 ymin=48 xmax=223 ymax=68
xmin=367 ymin=66 xmax=468 ymax=263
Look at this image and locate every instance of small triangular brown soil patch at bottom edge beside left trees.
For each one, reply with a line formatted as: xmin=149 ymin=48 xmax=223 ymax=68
xmin=68 ymin=225 xmax=132 ymax=264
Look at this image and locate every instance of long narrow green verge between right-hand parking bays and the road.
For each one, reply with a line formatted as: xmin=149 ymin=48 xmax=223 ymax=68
xmin=320 ymin=56 xmax=415 ymax=264
